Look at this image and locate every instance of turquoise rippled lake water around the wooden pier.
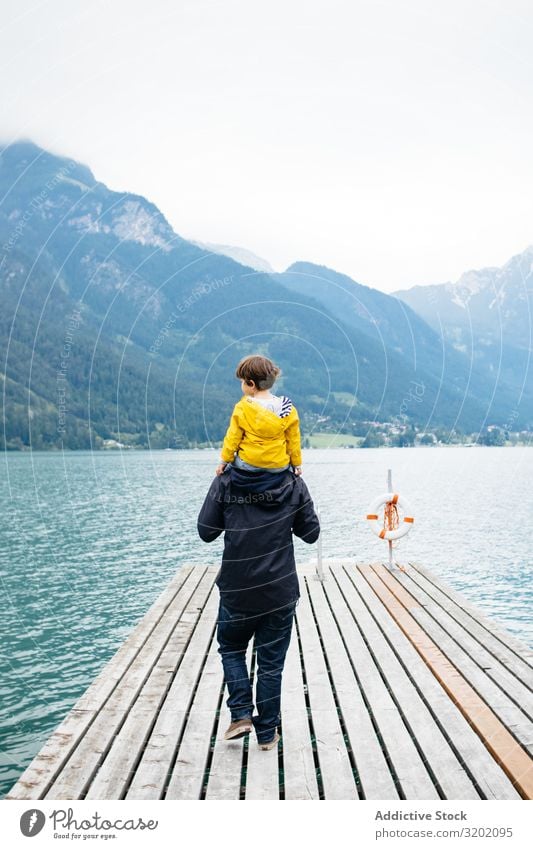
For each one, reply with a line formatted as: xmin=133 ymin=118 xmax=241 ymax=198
xmin=0 ymin=447 xmax=533 ymax=794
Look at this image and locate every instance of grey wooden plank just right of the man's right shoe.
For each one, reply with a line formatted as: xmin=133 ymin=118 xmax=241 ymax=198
xmin=281 ymin=627 xmax=319 ymax=800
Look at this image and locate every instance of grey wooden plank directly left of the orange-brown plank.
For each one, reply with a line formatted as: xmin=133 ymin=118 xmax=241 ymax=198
xmin=344 ymin=566 xmax=520 ymax=800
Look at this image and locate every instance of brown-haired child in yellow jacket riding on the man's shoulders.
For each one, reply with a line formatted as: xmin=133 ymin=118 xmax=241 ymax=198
xmin=216 ymin=354 xmax=302 ymax=475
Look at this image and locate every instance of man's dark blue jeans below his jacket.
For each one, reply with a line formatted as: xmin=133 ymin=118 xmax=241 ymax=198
xmin=217 ymin=601 xmax=297 ymax=743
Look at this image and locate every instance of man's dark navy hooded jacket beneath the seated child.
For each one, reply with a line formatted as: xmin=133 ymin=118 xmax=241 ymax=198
xmin=198 ymin=467 xmax=320 ymax=613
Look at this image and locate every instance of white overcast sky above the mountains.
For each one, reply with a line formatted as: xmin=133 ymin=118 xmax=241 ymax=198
xmin=0 ymin=0 xmax=533 ymax=291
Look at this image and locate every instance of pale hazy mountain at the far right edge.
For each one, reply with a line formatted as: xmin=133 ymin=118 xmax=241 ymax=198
xmin=396 ymin=246 xmax=533 ymax=422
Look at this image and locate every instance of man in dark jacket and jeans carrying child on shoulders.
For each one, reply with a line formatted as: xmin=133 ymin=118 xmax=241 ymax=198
xmin=198 ymin=465 xmax=320 ymax=750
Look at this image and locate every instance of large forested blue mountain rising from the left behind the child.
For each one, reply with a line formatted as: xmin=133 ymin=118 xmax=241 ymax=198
xmin=0 ymin=140 xmax=524 ymax=448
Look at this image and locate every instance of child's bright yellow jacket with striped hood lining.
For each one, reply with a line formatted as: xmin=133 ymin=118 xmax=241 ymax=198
xmin=221 ymin=395 xmax=302 ymax=469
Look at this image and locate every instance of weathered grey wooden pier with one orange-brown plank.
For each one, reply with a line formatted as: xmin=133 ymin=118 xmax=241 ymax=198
xmin=7 ymin=560 xmax=533 ymax=800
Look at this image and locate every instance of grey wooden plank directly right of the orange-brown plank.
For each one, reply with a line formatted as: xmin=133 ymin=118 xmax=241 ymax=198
xmin=374 ymin=566 xmax=533 ymax=752
